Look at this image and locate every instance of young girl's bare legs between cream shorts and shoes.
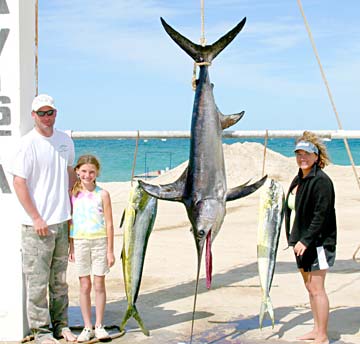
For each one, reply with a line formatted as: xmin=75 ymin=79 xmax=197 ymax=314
xmin=79 ymin=276 xmax=106 ymax=329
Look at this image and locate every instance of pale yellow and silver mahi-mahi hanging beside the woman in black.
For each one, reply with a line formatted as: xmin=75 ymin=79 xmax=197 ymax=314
xmin=257 ymin=179 xmax=284 ymax=329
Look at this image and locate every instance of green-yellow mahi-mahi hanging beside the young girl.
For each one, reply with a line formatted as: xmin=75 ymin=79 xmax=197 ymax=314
xmin=120 ymin=182 xmax=157 ymax=336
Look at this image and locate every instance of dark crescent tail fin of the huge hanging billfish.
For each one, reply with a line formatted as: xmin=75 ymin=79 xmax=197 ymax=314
xmin=160 ymin=18 xmax=246 ymax=62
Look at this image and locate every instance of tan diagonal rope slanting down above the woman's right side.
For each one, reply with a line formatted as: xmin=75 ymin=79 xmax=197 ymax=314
xmin=297 ymin=0 xmax=360 ymax=189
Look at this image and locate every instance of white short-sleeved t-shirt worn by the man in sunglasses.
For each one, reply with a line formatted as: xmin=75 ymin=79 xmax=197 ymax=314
xmin=11 ymin=128 xmax=75 ymax=225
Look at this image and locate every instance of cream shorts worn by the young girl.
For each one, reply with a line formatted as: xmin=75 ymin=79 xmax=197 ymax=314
xmin=74 ymin=238 xmax=109 ymax=277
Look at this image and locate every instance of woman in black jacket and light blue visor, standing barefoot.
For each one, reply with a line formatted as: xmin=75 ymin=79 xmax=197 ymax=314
xmin=285 ymin=131 xmax=336 ymax=344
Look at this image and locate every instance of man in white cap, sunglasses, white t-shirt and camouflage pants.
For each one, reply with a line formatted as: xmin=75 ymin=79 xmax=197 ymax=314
xmin=12 ymin=94 xmax=76 ymax=344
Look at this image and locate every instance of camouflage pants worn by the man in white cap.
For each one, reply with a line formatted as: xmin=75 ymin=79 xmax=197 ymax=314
xmin=21 ymin=222 xmax=69 ymax=335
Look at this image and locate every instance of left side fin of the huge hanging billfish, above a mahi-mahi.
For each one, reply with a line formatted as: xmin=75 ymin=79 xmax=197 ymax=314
xmin=139 ymin=168 xmax=188 ymax=202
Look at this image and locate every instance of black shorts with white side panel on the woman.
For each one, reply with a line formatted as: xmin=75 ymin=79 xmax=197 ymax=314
xmin=295 ymin=245 xmax=336 ymax=272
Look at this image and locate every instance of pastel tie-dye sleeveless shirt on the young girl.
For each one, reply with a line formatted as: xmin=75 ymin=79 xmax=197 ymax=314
xmin=70 ymin=186 xmax=107 ymax=239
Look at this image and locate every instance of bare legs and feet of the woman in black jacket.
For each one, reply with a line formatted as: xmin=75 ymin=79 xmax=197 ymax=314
xmin=298 ymin=269 xmax=329 ymax=344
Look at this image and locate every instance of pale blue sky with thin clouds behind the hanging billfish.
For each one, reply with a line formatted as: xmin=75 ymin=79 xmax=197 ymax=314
xmin=38 ymin=0 xmax=360 ymax=131
